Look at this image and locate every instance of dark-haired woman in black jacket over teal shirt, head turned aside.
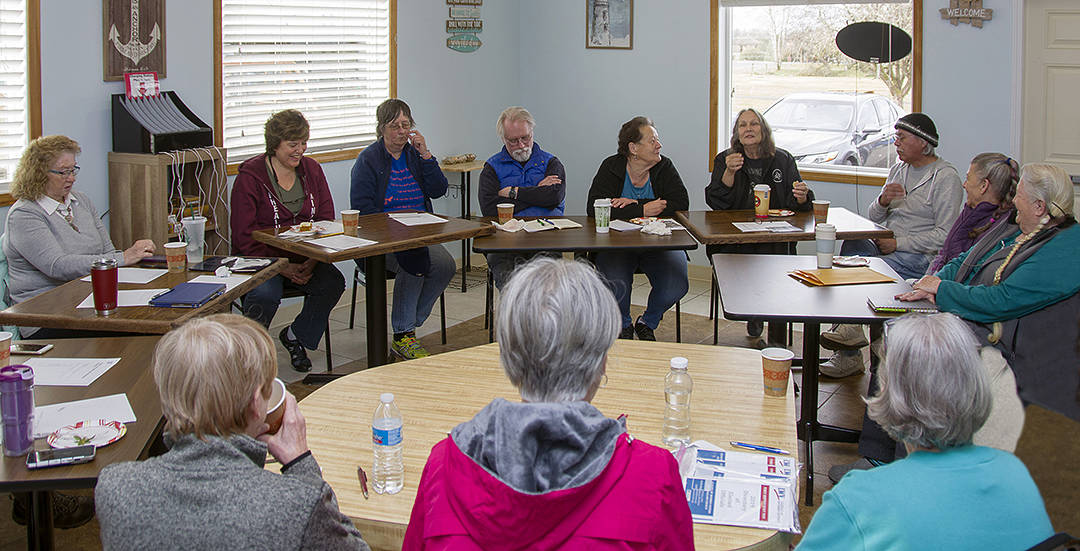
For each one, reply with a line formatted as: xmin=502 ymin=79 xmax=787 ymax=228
xmin=585 ymin=117 xmax=690 ymax=340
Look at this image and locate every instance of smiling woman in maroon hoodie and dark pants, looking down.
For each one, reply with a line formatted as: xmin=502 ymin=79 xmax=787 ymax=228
xmin=230 ymin=109 xmax=345 ymax=372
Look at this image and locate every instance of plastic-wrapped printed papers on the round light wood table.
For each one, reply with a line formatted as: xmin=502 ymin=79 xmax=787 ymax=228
xmin=676 ymin=441 xmax=801 ymax=534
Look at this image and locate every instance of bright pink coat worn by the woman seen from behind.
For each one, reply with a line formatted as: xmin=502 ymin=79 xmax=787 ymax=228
xmin=403 ymin=433 xmax=693 ymax=551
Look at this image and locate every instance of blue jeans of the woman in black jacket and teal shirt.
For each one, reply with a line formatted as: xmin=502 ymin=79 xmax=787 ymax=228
xmin=596 ymin=251 xmax=690 ymax=330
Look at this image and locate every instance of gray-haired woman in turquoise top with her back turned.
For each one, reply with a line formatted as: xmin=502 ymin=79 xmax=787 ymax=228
xmin=798 ymin=313 xmax=1054 ymax=550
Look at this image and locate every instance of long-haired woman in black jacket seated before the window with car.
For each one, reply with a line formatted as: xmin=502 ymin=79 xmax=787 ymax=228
xmin=705 ymin=108 xmax=813 ymax=337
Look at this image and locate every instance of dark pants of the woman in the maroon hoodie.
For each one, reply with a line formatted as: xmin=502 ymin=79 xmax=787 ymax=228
xmin=243 ymin=263 xmax=345 ymax=350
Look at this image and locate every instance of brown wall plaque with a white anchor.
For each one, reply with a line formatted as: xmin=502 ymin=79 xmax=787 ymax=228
xmin=102 ymin=0 xmax=165 ymax=81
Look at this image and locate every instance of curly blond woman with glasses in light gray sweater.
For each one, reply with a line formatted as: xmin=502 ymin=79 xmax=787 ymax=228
xmin=3 ymin=136 xmax=156 ymax=338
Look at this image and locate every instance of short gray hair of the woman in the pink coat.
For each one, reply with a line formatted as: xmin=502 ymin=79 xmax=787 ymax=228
xmin=495 ymin=257 xmax=622 ymax=402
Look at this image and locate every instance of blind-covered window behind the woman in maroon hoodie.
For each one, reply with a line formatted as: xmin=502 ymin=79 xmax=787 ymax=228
xmin=214 ymin=0 xmax=395 ymax=167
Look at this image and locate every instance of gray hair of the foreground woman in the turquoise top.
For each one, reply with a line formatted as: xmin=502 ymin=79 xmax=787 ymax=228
xmin=866 ymin=313 xmax=993 ymax=449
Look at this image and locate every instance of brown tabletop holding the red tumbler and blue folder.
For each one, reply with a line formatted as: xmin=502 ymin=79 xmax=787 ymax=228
xmin=0 ymin=258 xmax=286 ymax=335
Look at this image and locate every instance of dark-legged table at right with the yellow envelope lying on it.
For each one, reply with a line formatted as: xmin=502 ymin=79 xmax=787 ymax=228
xmin=713 ymin=254 xmax=912 ymax=506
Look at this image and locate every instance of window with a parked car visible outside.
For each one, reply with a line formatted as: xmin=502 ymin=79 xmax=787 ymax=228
xmin=710 ymin=0 xmax=922 ymax=184
